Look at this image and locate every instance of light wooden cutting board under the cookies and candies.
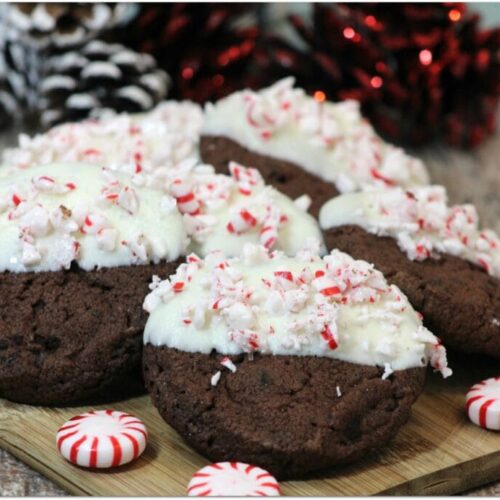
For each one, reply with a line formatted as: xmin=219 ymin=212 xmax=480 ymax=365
xmin=0 ymin=352 xmax=500 ymax=496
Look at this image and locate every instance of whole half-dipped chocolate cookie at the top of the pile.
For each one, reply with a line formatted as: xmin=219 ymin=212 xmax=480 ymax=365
xmin=200 ymin=78 xmax=428 ymax=215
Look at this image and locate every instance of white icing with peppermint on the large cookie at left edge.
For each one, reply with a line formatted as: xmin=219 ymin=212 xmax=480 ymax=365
xmin=0 ymin=164 xmax=187 ymax=272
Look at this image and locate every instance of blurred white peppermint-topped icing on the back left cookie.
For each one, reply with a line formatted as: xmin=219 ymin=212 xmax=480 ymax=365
xmin=0 ymin=101 xmax=203 ymax=176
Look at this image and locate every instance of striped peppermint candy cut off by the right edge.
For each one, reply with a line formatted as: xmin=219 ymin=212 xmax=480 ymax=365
xmin=465 ymin=377 xmax=500 ymax=431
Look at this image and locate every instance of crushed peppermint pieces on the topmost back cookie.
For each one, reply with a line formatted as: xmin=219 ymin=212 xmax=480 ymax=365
xmin=205 ymin=77 xmax=428 ymax=192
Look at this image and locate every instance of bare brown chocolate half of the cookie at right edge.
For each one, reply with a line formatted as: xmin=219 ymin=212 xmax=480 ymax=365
xmin=324 ymin=225 xmax=500 ymax=359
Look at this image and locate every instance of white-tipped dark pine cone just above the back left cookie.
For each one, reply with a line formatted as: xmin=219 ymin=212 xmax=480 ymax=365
xmin=39 ymin=40 xmax=170 ymax=127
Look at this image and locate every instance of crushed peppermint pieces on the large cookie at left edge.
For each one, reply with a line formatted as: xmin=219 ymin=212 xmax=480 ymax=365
xmin=0 ymin=164 xmax=184 ymax=271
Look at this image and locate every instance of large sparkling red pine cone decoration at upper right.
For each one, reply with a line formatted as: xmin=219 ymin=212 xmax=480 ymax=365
xmin=260 ymin=3 xmax=500 ymax=147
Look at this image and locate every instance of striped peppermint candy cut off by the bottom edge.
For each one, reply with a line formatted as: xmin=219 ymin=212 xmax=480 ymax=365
xmin=187 ymin=462 xmax=280 ymax=497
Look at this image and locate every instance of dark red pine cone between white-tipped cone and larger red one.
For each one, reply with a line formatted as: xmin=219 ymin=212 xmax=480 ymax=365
xmin=114 ymin=3 xmax=260 ymax=102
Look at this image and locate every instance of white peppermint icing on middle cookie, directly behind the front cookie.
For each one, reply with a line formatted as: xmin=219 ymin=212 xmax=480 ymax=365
xmin=161 ymin=160 xmax=323 ymax=256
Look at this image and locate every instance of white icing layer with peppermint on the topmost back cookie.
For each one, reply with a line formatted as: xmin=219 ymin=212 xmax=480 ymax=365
xmin=202 ymin=78 xmax=428 ymax=192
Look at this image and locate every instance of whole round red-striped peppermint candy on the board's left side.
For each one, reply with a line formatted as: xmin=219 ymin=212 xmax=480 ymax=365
xmin=57 ymin=410 xmax=148 ymax=469
